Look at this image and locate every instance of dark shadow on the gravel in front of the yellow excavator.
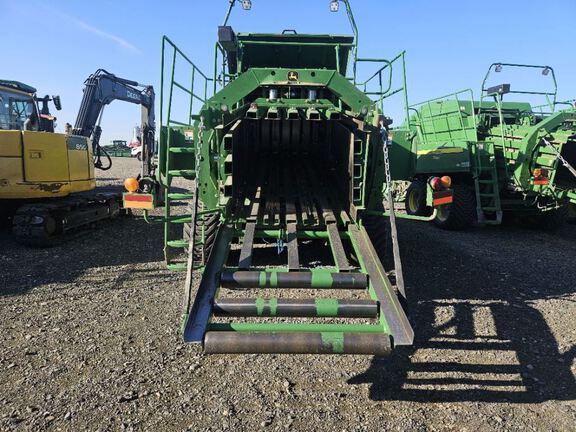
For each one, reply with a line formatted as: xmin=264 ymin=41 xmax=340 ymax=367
xmin=0 ymin=217 xmax=165 ymax=296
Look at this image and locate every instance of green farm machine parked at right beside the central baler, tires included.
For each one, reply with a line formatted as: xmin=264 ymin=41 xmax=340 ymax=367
xmin=399 ymin=63 xmax=576 ymax=229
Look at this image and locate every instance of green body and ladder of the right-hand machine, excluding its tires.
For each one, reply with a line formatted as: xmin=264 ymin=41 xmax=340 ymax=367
xmin=398 ymin=63 xmax=576 ymax=224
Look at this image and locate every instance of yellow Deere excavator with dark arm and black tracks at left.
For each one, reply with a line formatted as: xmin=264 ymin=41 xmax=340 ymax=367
xmin=0 ymin=69 xmax=155 ymax=247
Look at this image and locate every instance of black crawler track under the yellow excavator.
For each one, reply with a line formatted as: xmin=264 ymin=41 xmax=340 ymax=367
xmin=12 ymin=192 xmax=122 ymax=247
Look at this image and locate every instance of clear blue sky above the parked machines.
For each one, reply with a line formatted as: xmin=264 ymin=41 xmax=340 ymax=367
xmin=0 ymin=0 xmax=576 ymax=144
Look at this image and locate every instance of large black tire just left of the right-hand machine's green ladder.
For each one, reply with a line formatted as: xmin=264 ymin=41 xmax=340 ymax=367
xmin=434 ymin=185 xmax=476 ymax=231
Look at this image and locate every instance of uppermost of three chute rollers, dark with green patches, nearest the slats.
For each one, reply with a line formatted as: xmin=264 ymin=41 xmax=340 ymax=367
xmin=220 ymin=270 xmax=368 ymax=289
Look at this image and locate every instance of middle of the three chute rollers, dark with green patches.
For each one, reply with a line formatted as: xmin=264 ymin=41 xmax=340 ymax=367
xmin=214 ymin=297 xmax=378 ymax=318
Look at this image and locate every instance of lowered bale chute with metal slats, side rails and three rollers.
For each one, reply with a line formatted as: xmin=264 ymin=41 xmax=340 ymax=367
xmin=184 ymin=159 xmax=413 ymax=355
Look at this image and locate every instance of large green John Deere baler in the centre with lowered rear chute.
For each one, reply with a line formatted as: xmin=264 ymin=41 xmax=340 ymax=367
xmin=124 ymin=0 xmax=450 ymax=355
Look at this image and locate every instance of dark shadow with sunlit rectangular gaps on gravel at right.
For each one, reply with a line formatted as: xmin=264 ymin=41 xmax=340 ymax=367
xmin=348 ymin=221 xmax=576 ymax=403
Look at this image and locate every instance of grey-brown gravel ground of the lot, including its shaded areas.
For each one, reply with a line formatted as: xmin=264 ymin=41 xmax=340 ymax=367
xmin=0 ymin=159 xmax=576 ymax=431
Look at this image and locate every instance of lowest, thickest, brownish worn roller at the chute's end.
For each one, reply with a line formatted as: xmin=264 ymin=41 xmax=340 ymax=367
xmin=204 ymin=331 xmax=392 ymax=356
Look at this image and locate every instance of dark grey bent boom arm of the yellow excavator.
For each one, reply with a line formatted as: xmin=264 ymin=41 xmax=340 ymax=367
xmin=73 ymin=69 xmax=155 ymax=176
